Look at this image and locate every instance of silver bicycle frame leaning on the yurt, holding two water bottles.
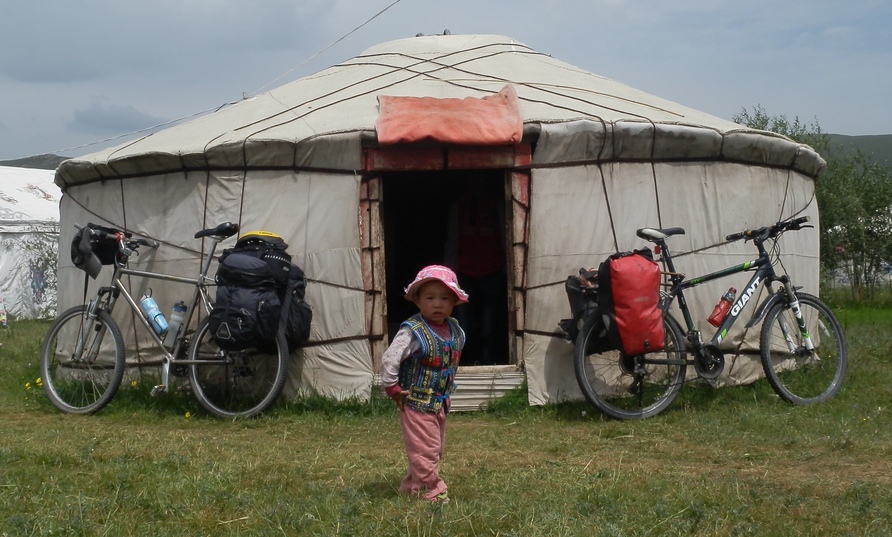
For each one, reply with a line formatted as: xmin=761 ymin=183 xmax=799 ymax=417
xmin=85 ymin=234 xmax=223 ymax=395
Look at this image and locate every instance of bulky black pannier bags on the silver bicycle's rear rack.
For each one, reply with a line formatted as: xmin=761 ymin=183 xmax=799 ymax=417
xmin=209 ymin=231 xmax=313 ymax=352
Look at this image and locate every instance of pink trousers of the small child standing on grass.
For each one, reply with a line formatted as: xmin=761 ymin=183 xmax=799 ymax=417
xmin=400 ymin=407 xmax=446 ymax=500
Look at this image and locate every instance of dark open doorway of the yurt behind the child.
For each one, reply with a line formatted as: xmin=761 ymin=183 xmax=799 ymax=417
xmin=381 ymin=170 xmax=510 ymax=365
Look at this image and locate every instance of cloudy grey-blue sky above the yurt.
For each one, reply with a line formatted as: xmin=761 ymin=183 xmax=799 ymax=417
xmin=0 ymin=0 xmax=892 ymax=160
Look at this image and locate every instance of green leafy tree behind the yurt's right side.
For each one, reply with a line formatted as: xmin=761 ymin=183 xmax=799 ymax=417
xmin=732 ymin=106 xmax=892 ymax=300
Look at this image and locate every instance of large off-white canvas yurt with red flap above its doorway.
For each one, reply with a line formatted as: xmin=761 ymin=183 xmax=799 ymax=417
xmin=56 ymin=35 xmax=824 ymax=404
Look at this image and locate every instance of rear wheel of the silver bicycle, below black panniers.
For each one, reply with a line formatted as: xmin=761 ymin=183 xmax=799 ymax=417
xmin=189 ymin=319 xmax=288 ymax=418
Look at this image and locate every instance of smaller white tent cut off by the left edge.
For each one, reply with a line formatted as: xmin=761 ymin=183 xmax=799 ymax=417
xmin=0 ymin=166 xmax=62 ymax=319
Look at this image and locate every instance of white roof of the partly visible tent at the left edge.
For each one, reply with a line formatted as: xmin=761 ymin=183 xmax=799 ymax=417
xmin=0 ymin=166 xmax=62 ymax=233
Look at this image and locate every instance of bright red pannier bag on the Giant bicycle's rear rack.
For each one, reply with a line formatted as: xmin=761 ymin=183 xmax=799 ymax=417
xmin=598 ymin=248 xmax=665 ymax=355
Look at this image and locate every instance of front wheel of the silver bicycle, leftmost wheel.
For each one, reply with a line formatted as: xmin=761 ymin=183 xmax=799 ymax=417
xmin=40 ymin=305 xmax=126 ymax=414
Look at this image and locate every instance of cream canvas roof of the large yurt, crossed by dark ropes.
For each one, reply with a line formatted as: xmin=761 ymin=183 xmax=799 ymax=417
xmin=56 ymin=35 xmax=824 ymax=188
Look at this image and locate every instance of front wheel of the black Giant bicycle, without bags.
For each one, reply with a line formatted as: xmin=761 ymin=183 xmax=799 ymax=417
xmin=759 ymin=293 xmax=848 ymax=405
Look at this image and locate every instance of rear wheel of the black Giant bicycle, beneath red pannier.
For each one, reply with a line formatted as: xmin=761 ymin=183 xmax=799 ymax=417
xmin=573 ymin=313 xmax=687 ymax=420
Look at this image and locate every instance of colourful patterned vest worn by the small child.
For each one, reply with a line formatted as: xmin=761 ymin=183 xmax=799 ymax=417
xmin=399 ymin=313 xmax=465 ymax=413
